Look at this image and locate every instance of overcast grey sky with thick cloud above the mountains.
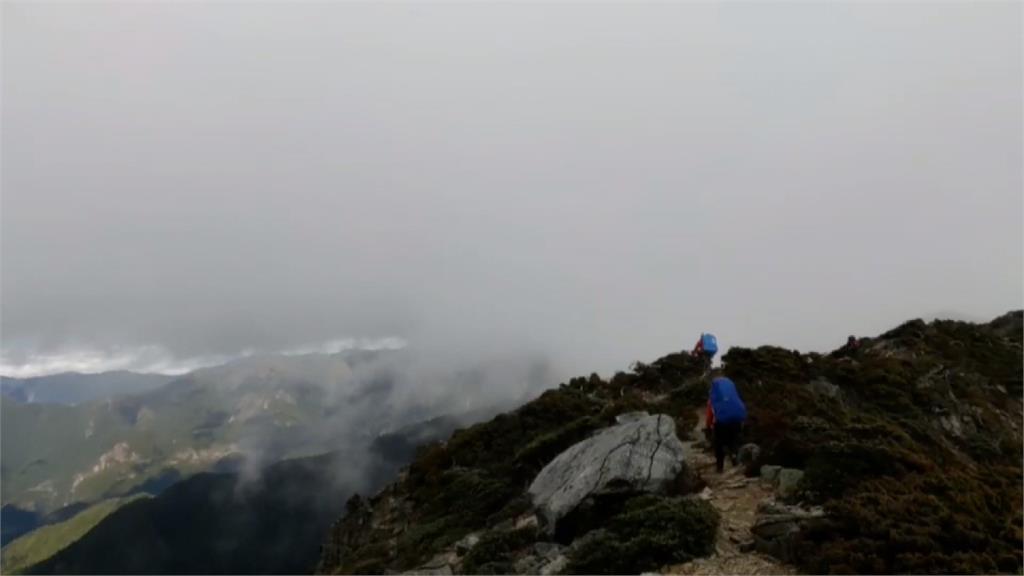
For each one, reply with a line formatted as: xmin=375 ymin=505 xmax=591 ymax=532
xmin=0 ymin=2 xmax=1024 ymax=374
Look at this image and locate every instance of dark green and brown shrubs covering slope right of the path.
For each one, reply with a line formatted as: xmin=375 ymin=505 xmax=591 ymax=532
xmin=723 ymin=313 xmax=1024 ymax=573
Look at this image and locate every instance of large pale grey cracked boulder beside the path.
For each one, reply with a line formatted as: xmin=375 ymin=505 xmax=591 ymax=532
xmin=529 ymin=412 xmax=684 ymax=531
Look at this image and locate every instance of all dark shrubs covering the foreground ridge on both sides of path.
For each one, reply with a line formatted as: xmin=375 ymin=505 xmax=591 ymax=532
xmin=318 ymin=312 xmax=1024 ymax=573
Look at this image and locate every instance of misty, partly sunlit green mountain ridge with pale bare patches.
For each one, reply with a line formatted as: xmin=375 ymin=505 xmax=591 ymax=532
xmin=0 ymin=344 xmax=544 ymax=516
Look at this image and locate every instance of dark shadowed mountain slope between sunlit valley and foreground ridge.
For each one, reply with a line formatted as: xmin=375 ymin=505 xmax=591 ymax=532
xmin=22 ymin=417 xmax=467 ymax=574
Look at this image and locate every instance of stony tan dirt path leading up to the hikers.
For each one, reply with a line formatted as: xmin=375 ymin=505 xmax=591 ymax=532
xmin=663 ymin=410 xmax=796 ymax=574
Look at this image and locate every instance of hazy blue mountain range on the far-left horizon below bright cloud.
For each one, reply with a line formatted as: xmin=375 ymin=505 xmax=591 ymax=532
xmin=0 ymin=370 xmax=175 ymax=406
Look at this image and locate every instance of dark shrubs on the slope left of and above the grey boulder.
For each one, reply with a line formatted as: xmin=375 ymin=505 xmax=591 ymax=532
xmin=319 ymin=355 xmax=700 ymax=573
